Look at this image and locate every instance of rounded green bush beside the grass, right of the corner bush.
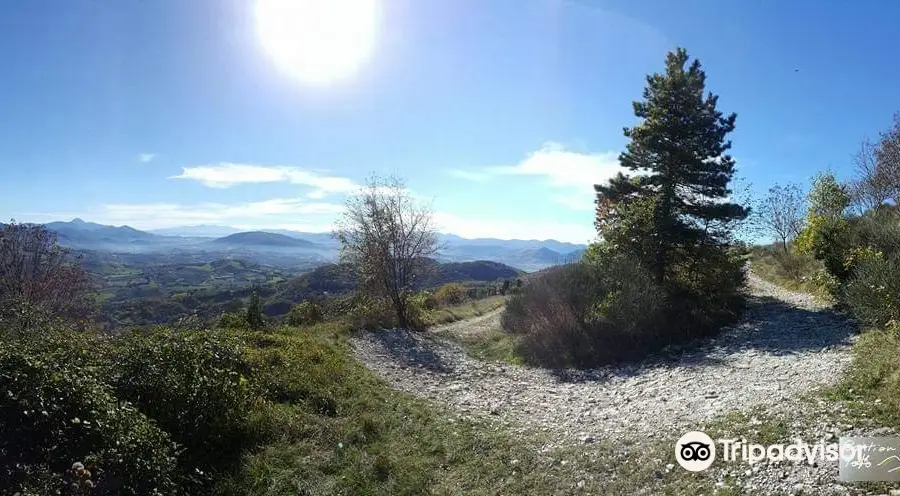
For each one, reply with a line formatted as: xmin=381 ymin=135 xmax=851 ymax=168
xmin=112 ymin=330 xmax=252 ymax=473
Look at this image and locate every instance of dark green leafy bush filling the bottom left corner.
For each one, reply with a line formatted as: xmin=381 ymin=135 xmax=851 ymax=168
xmin=0 ymin=336 xmax=178 ymax=495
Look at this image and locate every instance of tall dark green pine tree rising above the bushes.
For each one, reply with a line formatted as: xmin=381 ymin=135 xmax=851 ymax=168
xmin=595 ymin=48 xmax=748 ymax=282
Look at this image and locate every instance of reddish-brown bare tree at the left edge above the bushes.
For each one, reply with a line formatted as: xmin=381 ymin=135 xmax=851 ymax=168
xmin=0 ymin=221 xmax=89 ymax=335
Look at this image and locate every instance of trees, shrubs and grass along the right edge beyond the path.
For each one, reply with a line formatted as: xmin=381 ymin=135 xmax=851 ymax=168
xmin=752 ymin=114 xmax=900 ymax=438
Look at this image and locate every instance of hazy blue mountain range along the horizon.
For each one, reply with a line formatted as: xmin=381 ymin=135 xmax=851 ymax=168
xmin=31 ymin=219 xmax=586 ymax=271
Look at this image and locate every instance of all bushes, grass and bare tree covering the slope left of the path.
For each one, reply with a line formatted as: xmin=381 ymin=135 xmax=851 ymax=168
xmin=0 ymin=219 xmax=520 ymax=496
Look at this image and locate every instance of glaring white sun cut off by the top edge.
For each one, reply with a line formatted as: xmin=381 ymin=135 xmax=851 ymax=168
xmin=255 ymin=0 xmax=378 ymax=84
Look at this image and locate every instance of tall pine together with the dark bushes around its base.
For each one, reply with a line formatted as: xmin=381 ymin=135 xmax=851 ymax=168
xmin=503 ymin=49 xmax=749 ymax=367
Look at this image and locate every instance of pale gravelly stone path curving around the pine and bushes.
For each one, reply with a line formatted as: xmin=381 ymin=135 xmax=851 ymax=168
xmin=353 ymin=275 xmax=900 ymax=494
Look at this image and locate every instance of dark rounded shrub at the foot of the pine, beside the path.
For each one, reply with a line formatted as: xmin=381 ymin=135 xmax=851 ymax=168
xmin=501 ymin=248 xmax=664 ymax=367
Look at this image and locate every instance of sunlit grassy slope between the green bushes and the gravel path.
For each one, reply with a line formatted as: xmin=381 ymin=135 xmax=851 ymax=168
xmin=217 ymin=318 xmax=744 ymax=495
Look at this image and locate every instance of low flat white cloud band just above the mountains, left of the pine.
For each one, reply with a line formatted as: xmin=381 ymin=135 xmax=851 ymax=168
xmin=434 ymin=212 xmax=597 ymax=243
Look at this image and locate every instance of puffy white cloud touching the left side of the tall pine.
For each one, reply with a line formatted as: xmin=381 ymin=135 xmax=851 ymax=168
xmin=447 ymin=142 xmax=625 ymax=211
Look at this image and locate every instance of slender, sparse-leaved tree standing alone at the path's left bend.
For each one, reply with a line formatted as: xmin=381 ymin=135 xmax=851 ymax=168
xmin=333 ymin=176 xmax=439 ymax=327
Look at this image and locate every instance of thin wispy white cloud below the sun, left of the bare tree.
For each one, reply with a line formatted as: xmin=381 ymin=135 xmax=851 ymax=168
xmin=170 ymin=162 xmax=359 ymax=199
